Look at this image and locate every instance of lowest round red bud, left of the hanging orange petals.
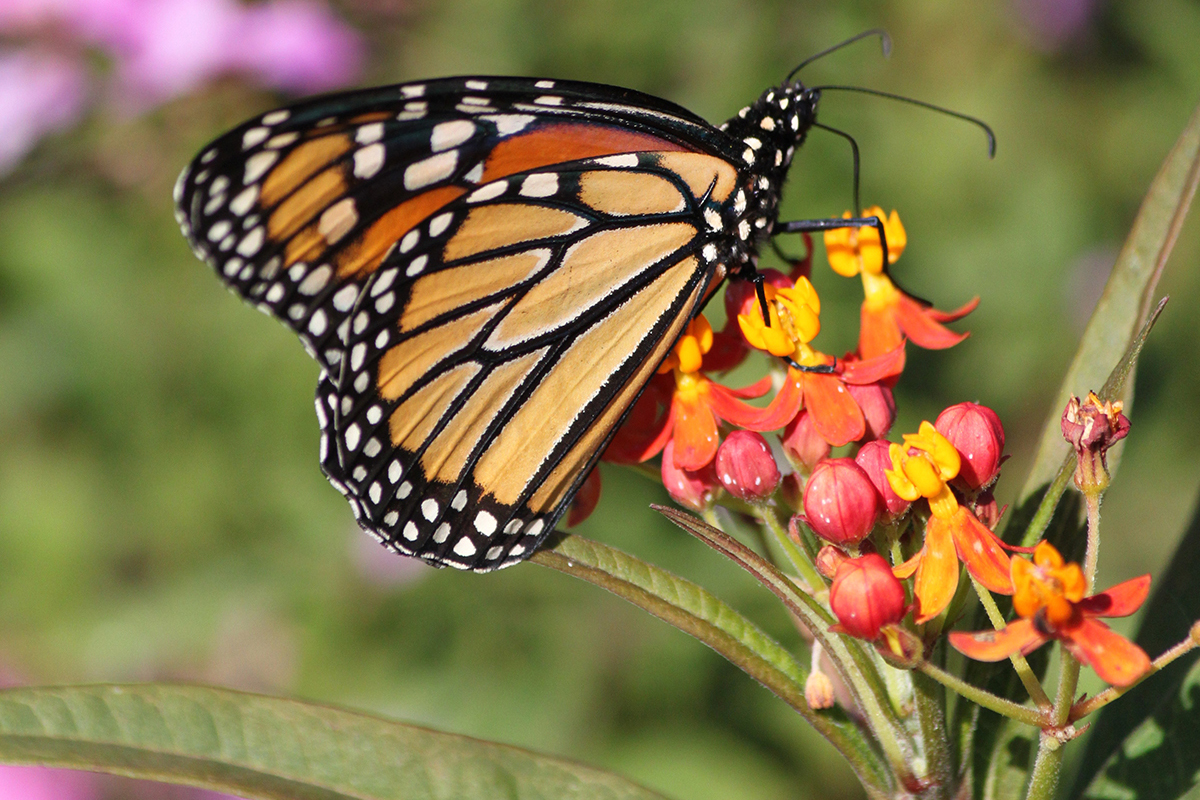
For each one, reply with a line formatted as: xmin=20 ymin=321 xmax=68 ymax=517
xmin=829 ymin=553 xmax=908 ymax=640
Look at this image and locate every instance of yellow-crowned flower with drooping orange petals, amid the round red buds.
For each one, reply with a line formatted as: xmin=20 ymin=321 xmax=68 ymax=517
xmin=884 ymin=422 xmax=1013 ymax=622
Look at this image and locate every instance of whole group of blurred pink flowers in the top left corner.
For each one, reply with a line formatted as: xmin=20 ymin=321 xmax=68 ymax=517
xmin=0 ymin=0 xmax=364 ymax=174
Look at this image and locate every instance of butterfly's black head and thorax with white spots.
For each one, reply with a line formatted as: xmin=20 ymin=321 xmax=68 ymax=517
xmin=721 ymin=82 xmax=821 ymax=273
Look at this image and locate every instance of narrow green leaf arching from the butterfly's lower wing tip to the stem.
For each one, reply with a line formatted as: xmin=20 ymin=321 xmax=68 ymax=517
xmin=530 ymin=534 xmax=890 ymax=796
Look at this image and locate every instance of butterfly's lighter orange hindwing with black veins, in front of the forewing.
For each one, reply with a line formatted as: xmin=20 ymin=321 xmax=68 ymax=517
xmin=334 ymin=152 xmax=732 ymax=570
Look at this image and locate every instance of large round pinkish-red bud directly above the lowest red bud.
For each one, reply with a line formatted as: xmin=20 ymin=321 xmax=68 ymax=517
xmin=804 ymin=458 xmax=883 ymax=545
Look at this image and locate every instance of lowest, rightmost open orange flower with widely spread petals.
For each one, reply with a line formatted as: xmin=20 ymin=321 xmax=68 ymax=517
xmin=950 ymin=542 xmax=1150 ymax=686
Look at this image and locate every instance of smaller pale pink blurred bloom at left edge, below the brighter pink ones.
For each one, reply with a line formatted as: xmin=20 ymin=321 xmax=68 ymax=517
xmin=0 ymin=49 xmax=88 ymax=175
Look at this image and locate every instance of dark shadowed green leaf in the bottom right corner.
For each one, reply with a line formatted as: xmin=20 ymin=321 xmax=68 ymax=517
xmin=1070 ymin=489 xmax=1200 ymax=800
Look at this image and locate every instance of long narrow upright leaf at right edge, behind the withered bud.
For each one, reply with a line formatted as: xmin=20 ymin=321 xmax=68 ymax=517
xmin=1021 ymin=100 xmax=1200 ymax=498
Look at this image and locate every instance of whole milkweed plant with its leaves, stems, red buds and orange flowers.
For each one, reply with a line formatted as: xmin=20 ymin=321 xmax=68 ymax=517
xmin=0 ymin=42 xmax=1200 ymax=800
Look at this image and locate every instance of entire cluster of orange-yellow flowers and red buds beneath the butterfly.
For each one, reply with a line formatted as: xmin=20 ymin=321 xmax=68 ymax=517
xmin=595 ymin=207 xmax=1166 ymax=724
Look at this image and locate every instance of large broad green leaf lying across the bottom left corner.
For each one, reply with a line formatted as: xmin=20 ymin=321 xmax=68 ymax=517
xmin=0 ymin=684 xmax=676 ymax=800
